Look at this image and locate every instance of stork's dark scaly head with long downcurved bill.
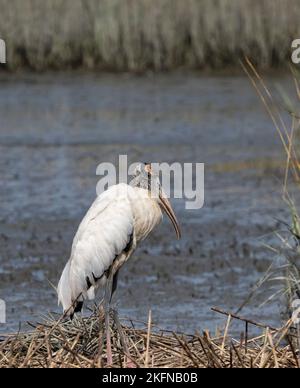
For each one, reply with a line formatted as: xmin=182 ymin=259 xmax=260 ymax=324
xmin=132 ymin=163 xmax=181 ymax=239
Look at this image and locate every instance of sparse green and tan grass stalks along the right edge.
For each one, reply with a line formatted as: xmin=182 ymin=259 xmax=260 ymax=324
xmin=239 ymin=58 xmax=300 ymax=354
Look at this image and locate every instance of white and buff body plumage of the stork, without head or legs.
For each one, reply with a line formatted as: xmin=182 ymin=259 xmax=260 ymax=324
xmin=57 ymin=184 xmax=162 ymax=311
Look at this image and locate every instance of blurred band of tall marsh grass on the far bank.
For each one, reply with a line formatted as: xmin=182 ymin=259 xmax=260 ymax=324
xmin=0 ymin=0 xmax=300 ymax=71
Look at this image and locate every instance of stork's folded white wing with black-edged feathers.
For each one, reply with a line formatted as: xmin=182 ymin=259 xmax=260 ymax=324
xmin=58 ymin=185 xmax=133 ymax=310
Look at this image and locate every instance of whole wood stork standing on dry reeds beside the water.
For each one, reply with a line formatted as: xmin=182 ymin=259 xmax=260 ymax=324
xmin=57 ymin=163 xmax=181 ymax=362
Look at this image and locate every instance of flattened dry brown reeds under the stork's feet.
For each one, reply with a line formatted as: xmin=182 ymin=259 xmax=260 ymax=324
xmin=0 ymin=313 xmax=300 ymax=368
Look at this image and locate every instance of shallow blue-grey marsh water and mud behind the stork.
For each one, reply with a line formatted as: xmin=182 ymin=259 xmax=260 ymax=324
xmin=0 ymin=74 xmax=296 ymax=332
